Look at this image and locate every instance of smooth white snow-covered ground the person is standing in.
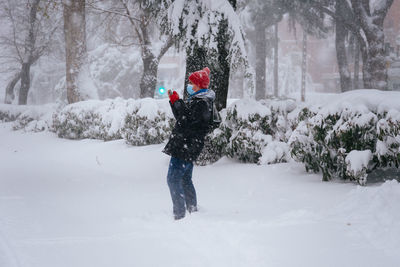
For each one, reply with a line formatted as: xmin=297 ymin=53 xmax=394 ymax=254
xmin=0 ymin=123 xmax=400 ymax=267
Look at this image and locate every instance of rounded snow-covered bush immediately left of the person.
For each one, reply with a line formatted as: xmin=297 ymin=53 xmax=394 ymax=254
xmin=123 ymin=98 xmax=174 ymax=146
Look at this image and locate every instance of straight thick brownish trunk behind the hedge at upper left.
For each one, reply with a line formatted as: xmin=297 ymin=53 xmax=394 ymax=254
xmin=63 ymin=0 xmax=87 ymax=103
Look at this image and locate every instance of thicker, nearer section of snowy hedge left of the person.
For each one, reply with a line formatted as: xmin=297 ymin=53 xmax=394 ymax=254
xmin=53 ymin=98 xmax=172 ymax=145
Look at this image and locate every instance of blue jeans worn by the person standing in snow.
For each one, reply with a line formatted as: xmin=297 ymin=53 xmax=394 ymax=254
xmin=167 ymin=157 xmax=197 ymax=218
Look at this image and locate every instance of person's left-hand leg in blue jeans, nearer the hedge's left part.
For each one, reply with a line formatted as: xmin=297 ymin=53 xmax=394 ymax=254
xmin=167 ymin=157 xmax=185 ymax=219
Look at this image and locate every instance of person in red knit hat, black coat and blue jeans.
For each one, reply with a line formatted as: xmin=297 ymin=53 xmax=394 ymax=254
xmin=163 ymin=67 xmax=215 ymax=220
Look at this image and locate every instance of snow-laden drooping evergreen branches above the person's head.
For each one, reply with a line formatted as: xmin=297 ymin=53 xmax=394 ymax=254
xmin=168 ymin=0 xmax=255 ymax=95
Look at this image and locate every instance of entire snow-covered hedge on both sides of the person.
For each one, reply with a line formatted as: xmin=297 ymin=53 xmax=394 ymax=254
xmin=0 ymin=90 xmax=400 ymax=184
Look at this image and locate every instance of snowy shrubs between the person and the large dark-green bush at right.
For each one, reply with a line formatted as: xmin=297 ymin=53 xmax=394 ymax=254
xmin=197 ymin=99 xmax=296 ymax=165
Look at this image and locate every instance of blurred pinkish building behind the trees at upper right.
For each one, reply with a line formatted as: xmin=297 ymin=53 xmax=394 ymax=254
xmin=279 ymin=0 xmax=400 ymax=92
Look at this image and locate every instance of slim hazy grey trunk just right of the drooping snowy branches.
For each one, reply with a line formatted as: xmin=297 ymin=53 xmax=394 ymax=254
xmin=255 ymin=23 xmax=267 ymax=100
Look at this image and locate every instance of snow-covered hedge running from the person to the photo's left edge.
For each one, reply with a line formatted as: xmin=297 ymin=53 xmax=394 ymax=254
xmin=0 ymin=98 xmax=174 ymax=145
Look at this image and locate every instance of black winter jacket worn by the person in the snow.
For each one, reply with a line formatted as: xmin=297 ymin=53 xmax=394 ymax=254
xmin=163 ymin=90 xmax=215 ymax=161
